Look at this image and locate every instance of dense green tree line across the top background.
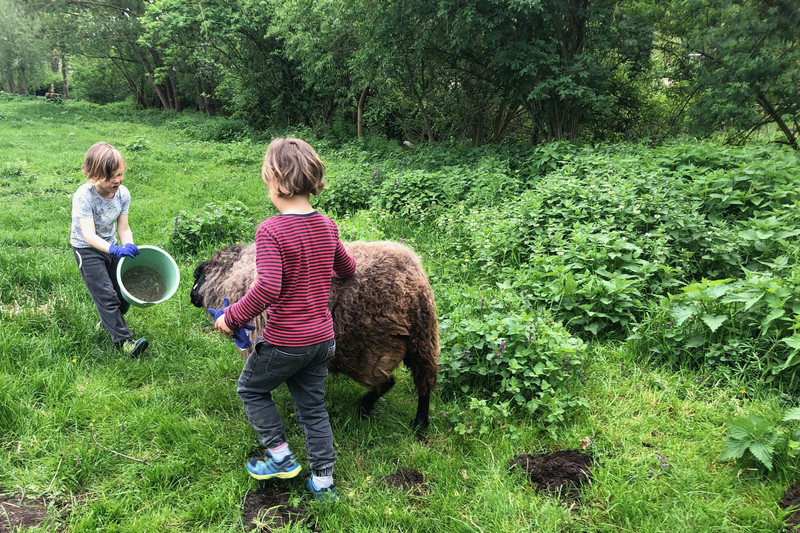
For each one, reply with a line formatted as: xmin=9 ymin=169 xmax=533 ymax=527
xmin=0 ymin=0 xmax=800 ymax=149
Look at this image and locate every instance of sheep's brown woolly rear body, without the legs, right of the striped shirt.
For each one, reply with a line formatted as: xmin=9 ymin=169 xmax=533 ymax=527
xmin=329 ymin=241 xmax=439 ymax=394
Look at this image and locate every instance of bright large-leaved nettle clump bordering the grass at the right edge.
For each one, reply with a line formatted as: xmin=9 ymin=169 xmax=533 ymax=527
xmin=629 ymin=268 xmax=800 ymax=387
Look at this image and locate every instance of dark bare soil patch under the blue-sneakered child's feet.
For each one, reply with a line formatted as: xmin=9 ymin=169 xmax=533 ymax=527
xmin=242 ymin=484 xmax=306 ymax=533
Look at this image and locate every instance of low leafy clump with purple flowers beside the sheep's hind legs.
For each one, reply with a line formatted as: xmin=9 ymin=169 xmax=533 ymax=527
xmin=439 ymin=294 xmax=587 ymax=438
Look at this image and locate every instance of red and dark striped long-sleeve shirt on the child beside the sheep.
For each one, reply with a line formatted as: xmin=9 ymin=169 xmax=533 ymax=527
xmin=225 ymin=211 xmax=356 ymax=346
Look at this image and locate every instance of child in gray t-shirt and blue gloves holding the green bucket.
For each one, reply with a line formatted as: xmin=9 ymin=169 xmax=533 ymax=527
xmin=70 ymin=142 xmax=148 ymax=357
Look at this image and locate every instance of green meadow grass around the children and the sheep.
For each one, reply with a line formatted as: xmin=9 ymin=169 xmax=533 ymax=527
xmin=0 ymin=97 xmax=786 ymax=533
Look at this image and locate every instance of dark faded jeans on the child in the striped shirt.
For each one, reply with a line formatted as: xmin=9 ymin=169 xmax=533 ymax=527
xmin=237 ymin=339 xmax=336 ymax=476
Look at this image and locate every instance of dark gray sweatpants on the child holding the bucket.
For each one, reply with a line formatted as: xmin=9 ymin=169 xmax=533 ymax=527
xmin=72 ymin=247 xmax=133 ymax=344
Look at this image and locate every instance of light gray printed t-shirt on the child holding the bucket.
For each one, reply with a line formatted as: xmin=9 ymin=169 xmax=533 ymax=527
xmin=69 ymin=183 xmax=131 ymax=248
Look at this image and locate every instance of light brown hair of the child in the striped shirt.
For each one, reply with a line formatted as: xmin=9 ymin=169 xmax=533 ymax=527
xmin=261 ymin=137 xmax=325 ymax=198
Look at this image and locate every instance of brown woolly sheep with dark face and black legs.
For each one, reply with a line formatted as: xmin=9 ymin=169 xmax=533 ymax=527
xmin=190 ymin=241 xmax=439 ymax=430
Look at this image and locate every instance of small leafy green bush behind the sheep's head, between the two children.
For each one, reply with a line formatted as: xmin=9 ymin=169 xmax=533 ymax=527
xmin=169 ymin=200 xmax=256 ymax=253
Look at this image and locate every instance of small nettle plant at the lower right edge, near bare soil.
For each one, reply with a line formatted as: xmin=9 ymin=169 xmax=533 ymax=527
xmin=719 ymin=407 xmax=800 ymax=477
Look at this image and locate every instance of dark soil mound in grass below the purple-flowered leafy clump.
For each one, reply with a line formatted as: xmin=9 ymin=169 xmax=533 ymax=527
xmin=508 ymin=450 xmax=592 ymax=500
